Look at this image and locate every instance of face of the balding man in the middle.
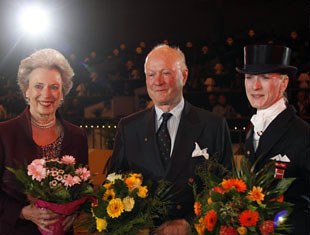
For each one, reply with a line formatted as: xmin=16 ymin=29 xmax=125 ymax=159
xmin=145 ymin=50 xmax=188 ymax=108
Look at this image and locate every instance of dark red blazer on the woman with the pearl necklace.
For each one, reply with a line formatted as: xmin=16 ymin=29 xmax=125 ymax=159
xmin=0 ymin=107 xmax=88 ymax=235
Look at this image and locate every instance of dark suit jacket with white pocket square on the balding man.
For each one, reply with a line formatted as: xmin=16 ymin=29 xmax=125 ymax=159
xmin=108 ymin=102 xmax=232 ymax=221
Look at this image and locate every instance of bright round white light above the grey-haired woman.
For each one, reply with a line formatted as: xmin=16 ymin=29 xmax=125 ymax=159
xmin=19 ymin=5 xmax=50 ymax=36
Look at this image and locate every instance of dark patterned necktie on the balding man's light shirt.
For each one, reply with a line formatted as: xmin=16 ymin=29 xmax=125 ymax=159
xmin=156 ymin=113 xmax=172 ymax=167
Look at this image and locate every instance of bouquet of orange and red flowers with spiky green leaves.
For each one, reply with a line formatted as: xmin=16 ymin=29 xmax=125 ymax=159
xmin=193 ymin=158 xmax=294 ymax=235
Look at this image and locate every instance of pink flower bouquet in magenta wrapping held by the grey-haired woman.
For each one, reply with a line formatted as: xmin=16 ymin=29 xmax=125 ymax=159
xmin=8 ymin=155 xmax=94 ymax=235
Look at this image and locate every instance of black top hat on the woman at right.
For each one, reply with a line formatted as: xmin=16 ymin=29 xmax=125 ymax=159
xmin=236 ymin=45 xmax=297 ymax=77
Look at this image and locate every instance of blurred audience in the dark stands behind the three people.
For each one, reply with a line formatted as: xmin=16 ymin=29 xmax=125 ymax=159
xmin=0 ymin=28 xmax=310 ymax=119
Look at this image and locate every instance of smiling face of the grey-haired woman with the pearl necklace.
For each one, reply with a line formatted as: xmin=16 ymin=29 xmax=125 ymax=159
xmin=26 ymin=68 xmax=63 ymax=119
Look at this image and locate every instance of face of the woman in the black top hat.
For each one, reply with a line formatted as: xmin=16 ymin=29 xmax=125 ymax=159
xmin=244 ymin=73 xmax=288 ymax=109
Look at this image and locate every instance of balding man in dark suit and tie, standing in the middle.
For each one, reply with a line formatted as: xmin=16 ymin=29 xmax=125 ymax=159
xmin=108 ymin=45 xmax=232 ymax=235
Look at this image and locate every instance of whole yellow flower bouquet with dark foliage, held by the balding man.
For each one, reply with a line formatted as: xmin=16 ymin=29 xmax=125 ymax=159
xmin=80 ymin=173 xmax=184 ymax=235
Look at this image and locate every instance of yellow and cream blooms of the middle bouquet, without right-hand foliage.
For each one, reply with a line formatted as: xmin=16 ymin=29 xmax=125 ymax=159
xmin=90 ymin=173 xmax=151 ymax=234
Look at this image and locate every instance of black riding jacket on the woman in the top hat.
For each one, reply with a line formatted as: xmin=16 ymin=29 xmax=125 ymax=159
xmin=245 ymin=106 xmax=310 ymax=235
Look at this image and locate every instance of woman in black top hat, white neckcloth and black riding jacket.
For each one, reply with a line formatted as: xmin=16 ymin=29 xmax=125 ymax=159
xmin=236 ymin=45 xmax=310 ymax=235
